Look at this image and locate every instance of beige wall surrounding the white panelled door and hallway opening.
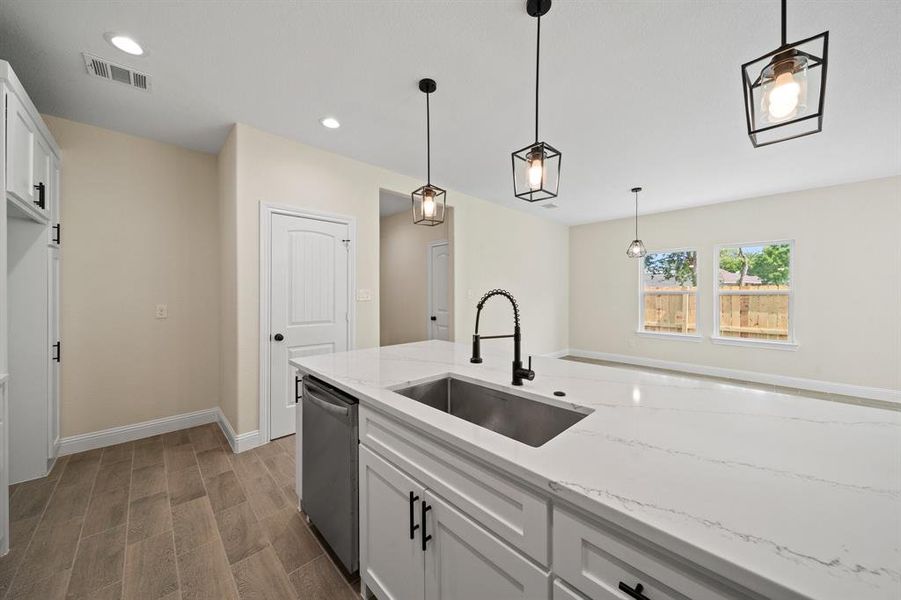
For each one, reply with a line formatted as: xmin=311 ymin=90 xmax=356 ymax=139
xmin=220 ymin=124 xmax=569 ymax=433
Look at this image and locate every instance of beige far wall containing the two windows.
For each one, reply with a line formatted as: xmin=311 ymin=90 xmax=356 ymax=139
xmin=570 ymin=177 xmax=901 ymax=390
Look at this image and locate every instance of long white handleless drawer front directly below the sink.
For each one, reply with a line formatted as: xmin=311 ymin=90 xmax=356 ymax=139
xmin=360 ymin=407 xmax=548 ymax=565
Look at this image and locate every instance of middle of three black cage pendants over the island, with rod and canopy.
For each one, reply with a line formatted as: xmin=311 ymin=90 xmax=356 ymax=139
xmin=513 ymin=0 xmax=562 ymax=202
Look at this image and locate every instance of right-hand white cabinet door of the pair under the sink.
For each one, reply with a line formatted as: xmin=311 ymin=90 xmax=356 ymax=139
xmin=420 ymin=491 xmax=550 ymax=600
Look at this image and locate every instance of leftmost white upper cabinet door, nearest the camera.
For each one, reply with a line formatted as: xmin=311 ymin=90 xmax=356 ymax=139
xmin=6 ymin=92 xmax=35 ymax=206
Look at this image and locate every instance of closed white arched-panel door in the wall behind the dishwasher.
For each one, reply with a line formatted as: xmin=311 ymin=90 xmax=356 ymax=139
xmin=269 ymin=214 xmax=350 ymax=439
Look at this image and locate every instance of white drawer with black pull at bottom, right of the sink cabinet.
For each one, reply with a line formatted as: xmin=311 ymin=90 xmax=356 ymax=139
xmin=553 ymin=507 xmax=744 ymax=600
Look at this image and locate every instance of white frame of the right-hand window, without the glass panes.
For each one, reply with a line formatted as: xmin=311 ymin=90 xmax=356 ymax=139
xmin=710 ymin=239 xmax=798 ymax=350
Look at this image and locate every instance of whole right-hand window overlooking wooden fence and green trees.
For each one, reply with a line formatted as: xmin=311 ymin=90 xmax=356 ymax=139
xmin=714 ymin=241 xmax=794 ymax=346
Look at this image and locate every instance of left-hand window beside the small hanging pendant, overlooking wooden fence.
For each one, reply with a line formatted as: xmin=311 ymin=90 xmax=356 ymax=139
xmin=638 ymin=250 xmax=698 ymax=336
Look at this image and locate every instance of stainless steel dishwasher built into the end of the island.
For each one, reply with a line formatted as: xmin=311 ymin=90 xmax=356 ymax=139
xmin=301 ymin=376 xmax=360 ymax=573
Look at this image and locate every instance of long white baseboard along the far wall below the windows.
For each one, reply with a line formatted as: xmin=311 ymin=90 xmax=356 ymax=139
xmin=568 ymin=349 xmax=901 ymax=404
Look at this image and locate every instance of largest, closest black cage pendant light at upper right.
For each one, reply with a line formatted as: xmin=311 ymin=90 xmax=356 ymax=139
xmin=741 ymin=0 xmax=829 ymax=148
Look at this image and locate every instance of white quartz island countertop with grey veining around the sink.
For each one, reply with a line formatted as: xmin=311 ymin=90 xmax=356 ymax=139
xmin=291 ymin=341 xmax=901 ymax=600
